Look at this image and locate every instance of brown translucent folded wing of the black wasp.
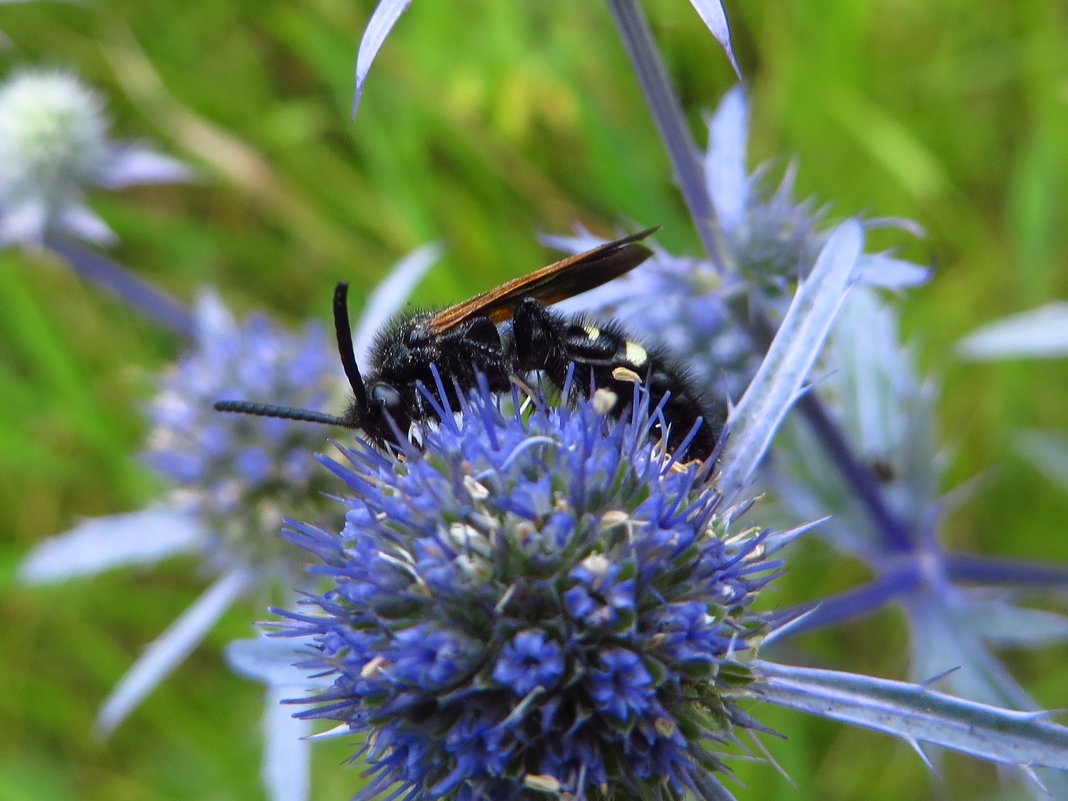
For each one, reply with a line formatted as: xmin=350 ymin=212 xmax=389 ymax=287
xmin=426 ymin=225 xmax=660 ymax=334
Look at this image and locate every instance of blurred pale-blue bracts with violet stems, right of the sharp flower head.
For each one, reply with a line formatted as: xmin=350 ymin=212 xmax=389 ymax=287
xmin=764 ymin=287 xmax=1068 ymax=797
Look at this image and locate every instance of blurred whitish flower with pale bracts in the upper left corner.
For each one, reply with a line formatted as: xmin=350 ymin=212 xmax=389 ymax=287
xmin=0 ymin=69 xmax=192 ymax=247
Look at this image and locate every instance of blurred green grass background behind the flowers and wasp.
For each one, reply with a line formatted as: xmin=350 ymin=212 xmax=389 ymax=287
xmin=0 ymin=0 xmax=1068 ymax=801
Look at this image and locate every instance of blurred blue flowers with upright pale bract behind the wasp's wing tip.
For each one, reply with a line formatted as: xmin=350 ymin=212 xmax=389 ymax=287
xmin=543 ymin=87 xmax=929 ymax=398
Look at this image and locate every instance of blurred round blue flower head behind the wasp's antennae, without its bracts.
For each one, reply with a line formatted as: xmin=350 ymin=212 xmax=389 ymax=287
xmin=144 ymin=295 xmax=339 ymax=578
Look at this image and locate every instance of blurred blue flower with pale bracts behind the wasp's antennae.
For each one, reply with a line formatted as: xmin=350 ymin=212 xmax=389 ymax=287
xmin=20 ymin=247 xmax=437 ymax=801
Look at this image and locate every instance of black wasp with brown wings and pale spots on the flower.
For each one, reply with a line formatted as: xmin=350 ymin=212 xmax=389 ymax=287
xmin=215 ymin=229 xmax=725 ymax=459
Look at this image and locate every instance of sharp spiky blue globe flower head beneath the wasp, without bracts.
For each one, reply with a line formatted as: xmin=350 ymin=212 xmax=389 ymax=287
xmin=279 ymin=391 xmax=779 ymax=801
